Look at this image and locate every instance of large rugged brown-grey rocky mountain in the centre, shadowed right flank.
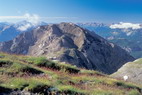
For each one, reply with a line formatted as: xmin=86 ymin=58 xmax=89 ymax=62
xmin=0 ymin=23 xmax=134 ymax=74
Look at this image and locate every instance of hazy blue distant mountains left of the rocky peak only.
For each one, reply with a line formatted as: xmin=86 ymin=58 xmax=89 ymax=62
xmin=0 ymin=21 xmax=47 ymax=42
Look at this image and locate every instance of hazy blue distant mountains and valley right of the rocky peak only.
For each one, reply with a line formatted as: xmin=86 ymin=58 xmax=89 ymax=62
xmin=78 ymin=23 xmax=142 ymax=58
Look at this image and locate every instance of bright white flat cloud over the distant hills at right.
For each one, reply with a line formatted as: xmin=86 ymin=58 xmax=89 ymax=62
xmin=110 ymin=22 xmax=142 ymax=29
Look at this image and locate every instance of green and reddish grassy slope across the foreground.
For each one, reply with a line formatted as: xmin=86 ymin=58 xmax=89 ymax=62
xmin=0 ymin=53 xmax=142 ymax=95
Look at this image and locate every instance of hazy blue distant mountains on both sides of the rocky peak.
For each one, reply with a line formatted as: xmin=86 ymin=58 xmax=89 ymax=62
xmin=0 ymin=21 xmax=142 ymax=58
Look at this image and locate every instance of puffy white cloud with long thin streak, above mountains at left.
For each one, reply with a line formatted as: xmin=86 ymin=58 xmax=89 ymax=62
xmin=0 ymin=11 xmax=77 ymax=31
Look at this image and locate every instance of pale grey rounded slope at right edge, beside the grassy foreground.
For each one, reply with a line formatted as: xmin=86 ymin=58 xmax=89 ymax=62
xmin=112 ymin=59 xmax=142 ymax=85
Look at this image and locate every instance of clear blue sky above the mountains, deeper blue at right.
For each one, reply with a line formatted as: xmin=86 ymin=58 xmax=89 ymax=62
xmin=0 ymin=0 xmax=142 ymax=23
